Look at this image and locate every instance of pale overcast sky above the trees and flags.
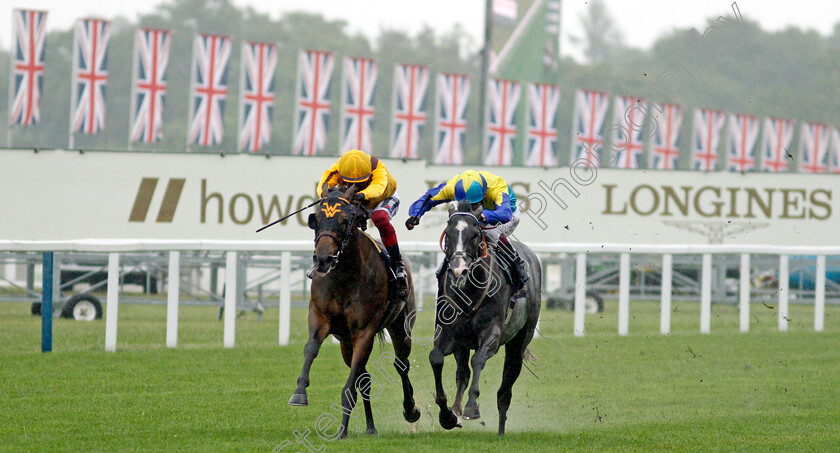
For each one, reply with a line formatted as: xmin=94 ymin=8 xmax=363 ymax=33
xmin=0 ymin=0 xmax=840 ymax=60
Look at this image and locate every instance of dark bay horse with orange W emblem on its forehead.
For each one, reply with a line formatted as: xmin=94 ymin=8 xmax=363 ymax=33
xmin=289 ymin=186 xmax=420 ymax=438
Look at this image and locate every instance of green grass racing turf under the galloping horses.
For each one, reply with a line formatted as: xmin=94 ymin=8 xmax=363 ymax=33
xmin=0 ymin=300 xmax=840 ymax=452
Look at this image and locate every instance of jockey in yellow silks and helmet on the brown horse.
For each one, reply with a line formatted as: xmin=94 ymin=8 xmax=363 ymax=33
xmin=317 ymin=149 xmax=408 ymax=298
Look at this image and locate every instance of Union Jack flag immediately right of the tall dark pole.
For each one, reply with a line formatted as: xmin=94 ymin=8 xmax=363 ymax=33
xmin=484 ymin=79 xmax=522 ymax=165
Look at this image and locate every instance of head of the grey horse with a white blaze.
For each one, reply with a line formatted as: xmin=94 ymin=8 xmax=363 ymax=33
xmin=444 ymin=201 xmax=487 ymax=278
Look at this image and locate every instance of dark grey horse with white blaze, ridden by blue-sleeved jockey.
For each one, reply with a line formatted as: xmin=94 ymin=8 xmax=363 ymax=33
xmin=429 ymin=203 xmax=542 ymax=436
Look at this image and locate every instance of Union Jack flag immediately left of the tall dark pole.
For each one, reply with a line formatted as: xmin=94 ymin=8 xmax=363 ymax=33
xmin=435 ymin=74 xmax=470 ymax=165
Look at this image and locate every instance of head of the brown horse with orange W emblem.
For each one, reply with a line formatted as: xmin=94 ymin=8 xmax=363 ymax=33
xmin=309 ymin=185 xmax=361 ymax=274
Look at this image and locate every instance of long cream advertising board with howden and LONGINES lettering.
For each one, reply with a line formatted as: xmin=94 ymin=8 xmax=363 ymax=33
xmin=0 ymin=151 xmax=840 ymax=245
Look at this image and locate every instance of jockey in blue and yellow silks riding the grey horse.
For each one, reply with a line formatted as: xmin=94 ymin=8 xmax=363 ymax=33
xmin=405 ymin=170 xmax=528 ymax=298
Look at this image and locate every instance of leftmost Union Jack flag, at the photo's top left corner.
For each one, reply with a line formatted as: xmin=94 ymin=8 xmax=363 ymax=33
xmin=9 ymin=9 xmax=47 ymax=126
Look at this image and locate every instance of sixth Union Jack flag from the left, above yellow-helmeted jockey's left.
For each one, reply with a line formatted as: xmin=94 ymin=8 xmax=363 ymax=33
xmin=292 ymin=50 xmax=335 ymax=156
